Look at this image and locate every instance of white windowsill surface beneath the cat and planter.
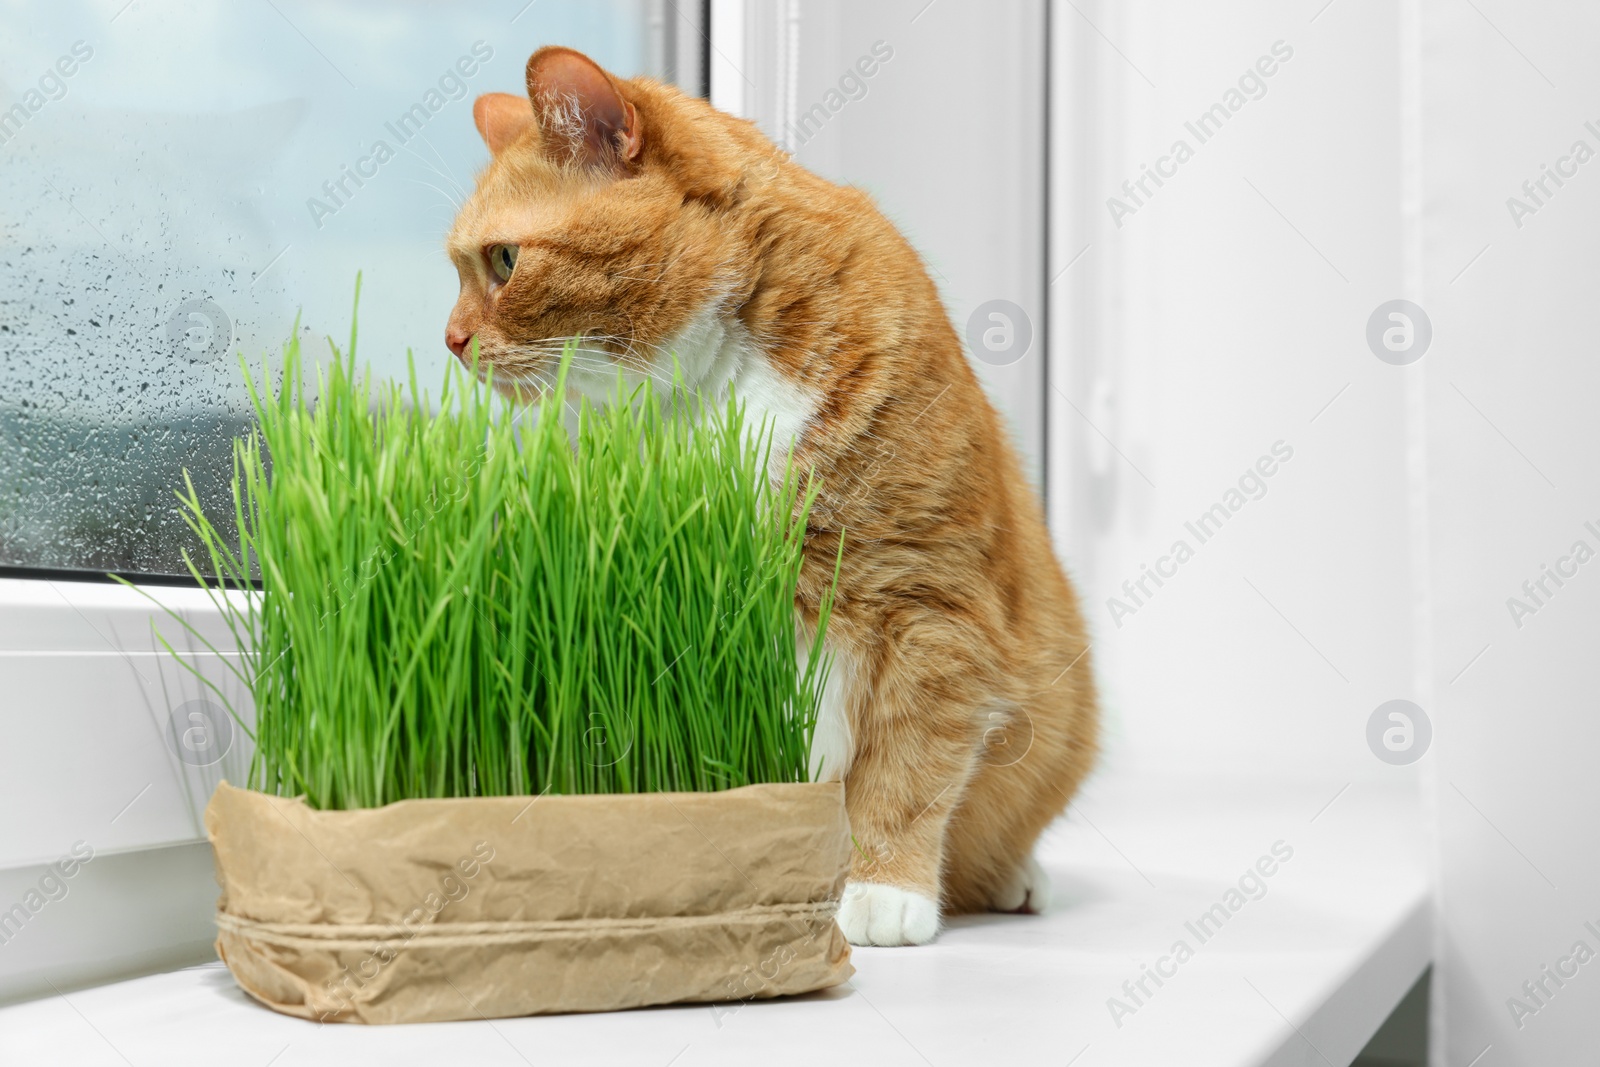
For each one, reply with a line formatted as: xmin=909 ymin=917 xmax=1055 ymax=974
xmin=0 ymin=771 xmax=1432 ymax=1067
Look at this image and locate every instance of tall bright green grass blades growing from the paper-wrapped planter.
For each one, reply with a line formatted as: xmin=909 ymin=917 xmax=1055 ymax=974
xmin=128 ymin=289 xmax=829 ymax=808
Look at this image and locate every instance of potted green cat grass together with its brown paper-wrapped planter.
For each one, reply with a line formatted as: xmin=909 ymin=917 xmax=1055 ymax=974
xmin=132 ymin=315 xmax=853 ymax=1022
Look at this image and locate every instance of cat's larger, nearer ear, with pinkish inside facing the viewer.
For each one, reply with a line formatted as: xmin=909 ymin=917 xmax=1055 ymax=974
xmin=528 ymin=46 xmax=643 ymax=170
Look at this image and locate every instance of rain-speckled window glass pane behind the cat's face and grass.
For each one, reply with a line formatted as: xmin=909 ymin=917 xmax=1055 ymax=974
xmin=0 ymin=0 xmax=681 ymax=574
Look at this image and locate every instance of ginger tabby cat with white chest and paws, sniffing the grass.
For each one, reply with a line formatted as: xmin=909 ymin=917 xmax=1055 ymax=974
xmin=446 ymin=48 xmax=1098 ymax=945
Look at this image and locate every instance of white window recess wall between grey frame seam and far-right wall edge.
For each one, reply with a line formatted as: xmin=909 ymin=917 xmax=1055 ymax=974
xmin=1051 ymin=0 xmax=1414 ymax=793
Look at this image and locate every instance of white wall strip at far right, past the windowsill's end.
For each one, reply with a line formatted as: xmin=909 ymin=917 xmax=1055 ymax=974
xmin=1419 ymin=0 xmax=1600 ymax=1067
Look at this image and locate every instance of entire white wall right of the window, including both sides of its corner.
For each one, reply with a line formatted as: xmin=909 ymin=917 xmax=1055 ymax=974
xmin=1050 ymin=0 xmax=1600 ymax=1067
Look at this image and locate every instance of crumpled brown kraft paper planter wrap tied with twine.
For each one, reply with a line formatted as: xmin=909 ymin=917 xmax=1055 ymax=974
xmin=205 ymin=782 xmax=854 ymax=1022
